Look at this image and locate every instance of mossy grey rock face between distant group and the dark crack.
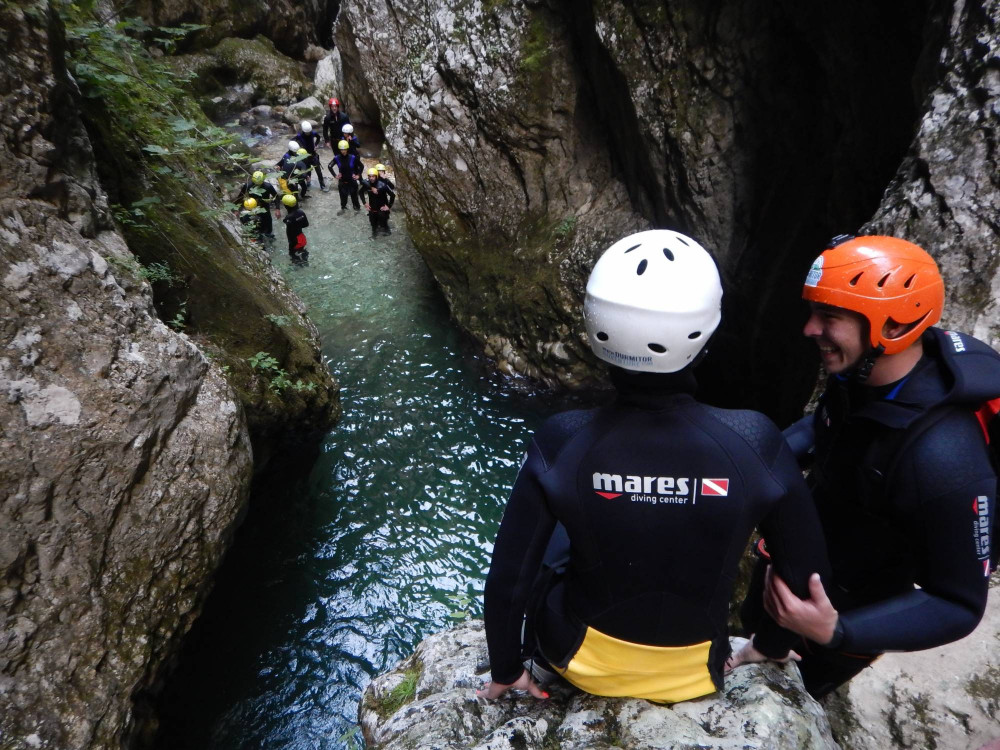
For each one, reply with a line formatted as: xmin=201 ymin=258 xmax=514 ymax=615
xmin=337 ymin=0 xmax=648 ymax=385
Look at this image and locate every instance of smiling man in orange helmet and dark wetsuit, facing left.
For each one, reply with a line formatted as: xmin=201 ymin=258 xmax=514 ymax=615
xmin=730 ymin=235 xmax=1000 ymax=697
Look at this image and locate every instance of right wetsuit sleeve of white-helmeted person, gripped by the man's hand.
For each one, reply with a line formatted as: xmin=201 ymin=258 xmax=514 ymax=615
xmin=754 ymin=440 xmax=832 ymax=658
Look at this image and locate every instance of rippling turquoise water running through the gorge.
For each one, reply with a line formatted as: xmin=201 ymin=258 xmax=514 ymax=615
xmin=157 ymin=179 xmax=588 ymax=749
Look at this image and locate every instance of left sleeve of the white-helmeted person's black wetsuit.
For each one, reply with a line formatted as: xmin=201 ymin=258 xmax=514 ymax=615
xmin=484 ymin=440 xmax=556 ymax=685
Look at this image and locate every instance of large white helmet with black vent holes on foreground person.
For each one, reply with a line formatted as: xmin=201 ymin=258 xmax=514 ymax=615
xmin=583 ymin=229 xmax=722 ymax=372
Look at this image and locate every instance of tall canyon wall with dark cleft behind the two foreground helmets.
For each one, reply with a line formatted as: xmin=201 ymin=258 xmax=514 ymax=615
xmin=336 ymin=0 xmax=997 ymax=420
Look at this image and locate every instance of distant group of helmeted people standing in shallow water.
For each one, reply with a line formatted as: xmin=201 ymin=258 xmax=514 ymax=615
xmin=236 ymin=98 xmax=396 ymax=264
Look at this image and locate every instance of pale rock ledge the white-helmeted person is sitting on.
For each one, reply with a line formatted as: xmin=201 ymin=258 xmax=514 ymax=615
xmin=359 ymin=621 xmax=838 ymax=750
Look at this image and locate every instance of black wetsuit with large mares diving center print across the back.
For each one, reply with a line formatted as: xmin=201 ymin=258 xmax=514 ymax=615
xmin=485 ymin=368 xmax=826 ymax=700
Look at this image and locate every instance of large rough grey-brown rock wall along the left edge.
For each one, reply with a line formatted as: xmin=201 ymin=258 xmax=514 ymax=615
xmin=0 ymin=2 xmax=251 ymax=748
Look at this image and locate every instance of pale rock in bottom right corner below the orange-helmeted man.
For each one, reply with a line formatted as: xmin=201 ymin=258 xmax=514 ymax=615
xmin=824 ymin=574 xmax=1000 ymax=750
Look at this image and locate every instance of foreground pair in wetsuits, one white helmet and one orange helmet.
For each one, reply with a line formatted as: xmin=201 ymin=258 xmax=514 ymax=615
xmin=478 ymin=230 xmax=1000 ymax=716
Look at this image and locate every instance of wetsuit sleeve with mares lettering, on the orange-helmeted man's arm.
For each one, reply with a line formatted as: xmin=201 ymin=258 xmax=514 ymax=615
xmin=840 ymin=414 xmax=996 ymax=653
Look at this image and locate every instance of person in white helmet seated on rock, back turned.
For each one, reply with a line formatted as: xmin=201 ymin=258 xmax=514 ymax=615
xmin=479 ymin=230 xmax=827 ymax=702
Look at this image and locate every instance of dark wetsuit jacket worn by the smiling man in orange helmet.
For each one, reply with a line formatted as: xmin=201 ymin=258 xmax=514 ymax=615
xmin=793 ymin=328 xmax=1000 ymax=654
